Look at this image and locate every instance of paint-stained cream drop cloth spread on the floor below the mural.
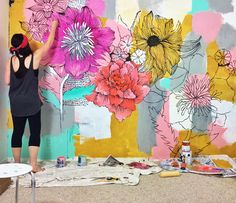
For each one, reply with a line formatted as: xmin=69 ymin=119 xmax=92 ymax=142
xmin=12 ymin=158 xmax=162 ymax=187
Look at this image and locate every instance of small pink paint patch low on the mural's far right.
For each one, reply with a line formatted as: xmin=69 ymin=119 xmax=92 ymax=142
xmin=208 ymin=123 xmax=228 ymax=148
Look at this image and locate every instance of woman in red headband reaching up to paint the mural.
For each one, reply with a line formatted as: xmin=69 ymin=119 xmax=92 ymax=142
xmin=5 ymin=20 xmax=58 ymax=172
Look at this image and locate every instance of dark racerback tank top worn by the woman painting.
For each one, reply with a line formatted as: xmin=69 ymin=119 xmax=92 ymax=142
xmin=9 ymin=54 xmax=42 ymax=116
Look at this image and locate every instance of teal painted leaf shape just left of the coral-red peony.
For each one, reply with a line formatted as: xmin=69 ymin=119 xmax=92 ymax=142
xmin=63 ymin=85 xmax=94 ymax=100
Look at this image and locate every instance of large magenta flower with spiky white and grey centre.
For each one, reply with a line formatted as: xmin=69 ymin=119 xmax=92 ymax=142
xmin=44 ymin=7 xmax=114 ymax=79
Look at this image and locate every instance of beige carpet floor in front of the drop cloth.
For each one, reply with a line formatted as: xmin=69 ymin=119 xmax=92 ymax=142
xmin=0 ymin=173 xmax=236 ymax=203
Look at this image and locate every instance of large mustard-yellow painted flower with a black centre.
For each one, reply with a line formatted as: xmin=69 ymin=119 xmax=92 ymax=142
xmin=131 ymin=12 xmax=182 ymax=81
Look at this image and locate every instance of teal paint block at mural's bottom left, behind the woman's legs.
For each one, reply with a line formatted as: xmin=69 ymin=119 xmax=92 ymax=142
xmin=8 ymin=124 xmax=79 ymax=160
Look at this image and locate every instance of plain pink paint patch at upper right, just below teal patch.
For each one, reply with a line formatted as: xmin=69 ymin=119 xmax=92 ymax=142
xmin=192 ymin=12 xmax=223 ymax=43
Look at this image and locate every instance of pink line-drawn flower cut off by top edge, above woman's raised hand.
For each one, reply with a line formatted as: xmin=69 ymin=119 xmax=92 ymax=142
xmin=28 ymin=0 xmax=68 ymax=19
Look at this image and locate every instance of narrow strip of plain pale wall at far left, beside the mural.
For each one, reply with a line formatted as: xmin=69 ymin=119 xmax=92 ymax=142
xmin=0 ymin=1 xmax=9 ymax=162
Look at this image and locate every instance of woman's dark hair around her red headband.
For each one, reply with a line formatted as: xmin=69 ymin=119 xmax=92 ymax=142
xmin=10 ymin=34 xmax=32 ymax=57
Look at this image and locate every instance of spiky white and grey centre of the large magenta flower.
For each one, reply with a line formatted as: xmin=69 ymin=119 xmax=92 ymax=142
xmin=61 ymin=22 xmax=94 ymax=60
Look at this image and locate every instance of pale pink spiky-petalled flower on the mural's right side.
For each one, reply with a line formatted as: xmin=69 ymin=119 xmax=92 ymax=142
xmin=177 ymin=75 xmax=218 ymax=116
